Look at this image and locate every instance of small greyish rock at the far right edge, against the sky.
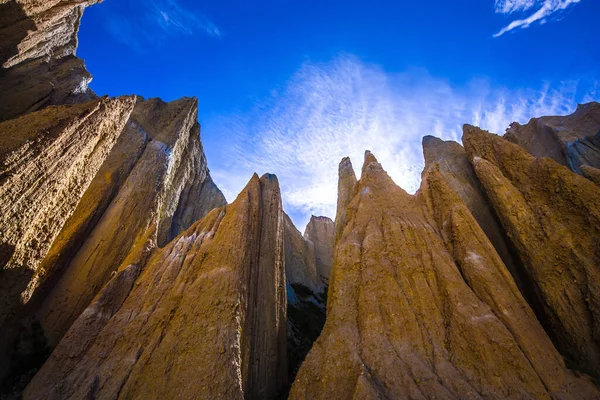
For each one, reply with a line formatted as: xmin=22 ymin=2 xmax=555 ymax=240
xmin=505 ymin=102 xmax=600 ymax=175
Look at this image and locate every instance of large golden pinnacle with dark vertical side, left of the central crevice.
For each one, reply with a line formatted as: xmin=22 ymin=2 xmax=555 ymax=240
xmin=24 ymin=175 xmax=287 ymax=399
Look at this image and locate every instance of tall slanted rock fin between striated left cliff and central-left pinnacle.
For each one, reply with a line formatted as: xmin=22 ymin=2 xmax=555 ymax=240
xmin=25 ymin=99 xmax=225 ymax=348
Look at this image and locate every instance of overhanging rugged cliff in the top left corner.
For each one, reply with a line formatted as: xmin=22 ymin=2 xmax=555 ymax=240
xmin=0 ymin=0 xmax=99 ymax=121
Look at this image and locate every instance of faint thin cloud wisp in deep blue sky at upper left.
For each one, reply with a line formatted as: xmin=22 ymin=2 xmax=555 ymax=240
xmin=105 ymin=0 xmax=222 ymax=53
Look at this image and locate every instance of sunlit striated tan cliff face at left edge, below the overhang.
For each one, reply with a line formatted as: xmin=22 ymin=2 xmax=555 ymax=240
xmin=0 ymin=97 xmax=135 ymax=325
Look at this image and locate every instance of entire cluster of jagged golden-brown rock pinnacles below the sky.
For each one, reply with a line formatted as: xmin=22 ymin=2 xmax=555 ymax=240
xmin=0 ymin=0 xmax=600 ymax=400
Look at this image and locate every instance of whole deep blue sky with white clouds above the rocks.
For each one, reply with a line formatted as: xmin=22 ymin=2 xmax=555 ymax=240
xmin=78 ymin=0 xmax=600 ymax=229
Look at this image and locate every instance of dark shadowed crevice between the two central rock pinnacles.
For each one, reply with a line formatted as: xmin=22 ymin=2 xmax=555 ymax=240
xmin=279 ymin=283 xmax=327 ymax=399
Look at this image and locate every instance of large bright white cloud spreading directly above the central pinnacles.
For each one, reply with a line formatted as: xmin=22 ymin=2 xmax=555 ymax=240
xmin=203 ymin=56 xmax=597 ymax=228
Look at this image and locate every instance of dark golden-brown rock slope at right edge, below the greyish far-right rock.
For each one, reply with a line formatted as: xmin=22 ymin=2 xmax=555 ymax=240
xmin=463 ymin=125 xmax=600 ymax=377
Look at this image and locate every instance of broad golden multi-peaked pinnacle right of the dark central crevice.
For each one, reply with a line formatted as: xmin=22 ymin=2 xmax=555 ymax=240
xmin=290 ymin=153 xmax=599 ymax=399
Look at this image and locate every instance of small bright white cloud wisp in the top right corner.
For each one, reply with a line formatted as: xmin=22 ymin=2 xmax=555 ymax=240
xmin=494 ymin=0 xmax=581 ymax=37
